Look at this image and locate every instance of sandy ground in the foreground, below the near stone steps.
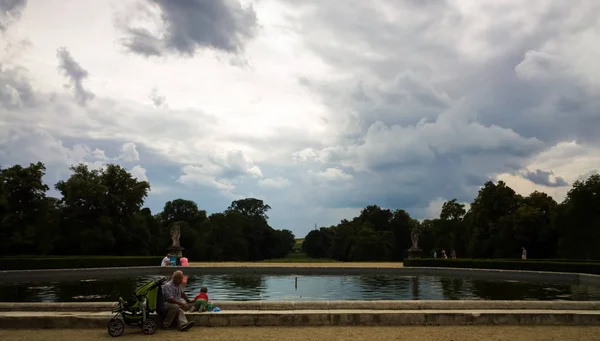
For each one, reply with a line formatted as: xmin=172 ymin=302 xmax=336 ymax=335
xmin=0 ymin=326 xmax=600 ymax=341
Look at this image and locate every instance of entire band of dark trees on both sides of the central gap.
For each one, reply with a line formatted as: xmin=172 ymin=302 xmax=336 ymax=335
xmin=0 ymin=162 xmax=600 ymax=261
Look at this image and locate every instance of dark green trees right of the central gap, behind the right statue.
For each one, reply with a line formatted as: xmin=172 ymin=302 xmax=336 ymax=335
xmin=302 ymin=174 xmax=600 ymax=261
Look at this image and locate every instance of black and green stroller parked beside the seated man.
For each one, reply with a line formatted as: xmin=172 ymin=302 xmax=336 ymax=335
xmin=108 ymin=278 xmax=167 ymax=337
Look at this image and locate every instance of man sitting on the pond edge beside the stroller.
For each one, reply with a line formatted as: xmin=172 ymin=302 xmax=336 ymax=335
xmin=162 ymin=270 xmax=194 ymax=331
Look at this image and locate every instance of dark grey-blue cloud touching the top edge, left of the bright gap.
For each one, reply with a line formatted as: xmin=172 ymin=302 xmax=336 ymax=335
xmin=123 ymin=0 xmax=257 ymax=56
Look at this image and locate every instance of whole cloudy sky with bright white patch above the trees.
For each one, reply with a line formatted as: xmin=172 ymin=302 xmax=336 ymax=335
xmin=0 ymin=0 xmax=600 ymax=237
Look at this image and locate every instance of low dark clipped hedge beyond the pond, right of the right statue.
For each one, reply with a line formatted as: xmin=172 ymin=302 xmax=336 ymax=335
xmin=404 ymin=258 xmax=600 ymax=274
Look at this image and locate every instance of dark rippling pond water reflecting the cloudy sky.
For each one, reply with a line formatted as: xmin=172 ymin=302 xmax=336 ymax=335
xmin=0 ymin=274 xmax=600 ymax=302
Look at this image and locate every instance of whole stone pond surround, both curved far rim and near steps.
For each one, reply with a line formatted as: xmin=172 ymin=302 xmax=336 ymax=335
xmin=0 ymin=265 xmax=600 ymax=329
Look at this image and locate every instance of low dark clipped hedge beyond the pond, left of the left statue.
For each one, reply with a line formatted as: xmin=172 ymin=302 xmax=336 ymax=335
xmin=0 ymin=256 xmax=164 ymax=270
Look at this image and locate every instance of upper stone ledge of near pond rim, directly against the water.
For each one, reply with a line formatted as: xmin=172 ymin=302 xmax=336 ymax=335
xmin=0 ymin=300 xmax=600 ymax=312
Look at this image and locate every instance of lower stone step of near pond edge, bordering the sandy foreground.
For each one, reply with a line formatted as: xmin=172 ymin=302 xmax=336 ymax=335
xmin=0 ymin=310 xmax=600 ymax=326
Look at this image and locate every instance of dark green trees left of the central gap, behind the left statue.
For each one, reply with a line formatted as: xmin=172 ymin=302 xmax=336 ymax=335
xmin=0 ymin=162 xmax=295 ymax=261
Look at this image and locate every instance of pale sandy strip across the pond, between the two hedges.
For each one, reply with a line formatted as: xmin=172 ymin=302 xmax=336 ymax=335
xmin=190 ymin=262 xmax=402 ymax=268
